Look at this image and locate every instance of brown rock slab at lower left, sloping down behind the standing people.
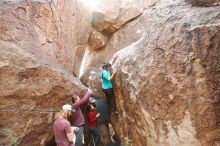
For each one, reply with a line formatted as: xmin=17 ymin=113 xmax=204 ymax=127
xmin=0 ymin=41 xmax=86 ymax=146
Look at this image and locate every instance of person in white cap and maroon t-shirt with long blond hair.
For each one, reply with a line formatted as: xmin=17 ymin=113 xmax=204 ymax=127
xmin=53 ymin=104 xmax=78 ymax=146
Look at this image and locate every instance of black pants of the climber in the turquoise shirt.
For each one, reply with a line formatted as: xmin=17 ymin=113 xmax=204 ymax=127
xmin=103 ymin=88 xmax=116 ymax=113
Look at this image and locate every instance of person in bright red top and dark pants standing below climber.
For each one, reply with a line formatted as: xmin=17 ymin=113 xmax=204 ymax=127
xmin=87 ymin=104 xmax=100 ymax=146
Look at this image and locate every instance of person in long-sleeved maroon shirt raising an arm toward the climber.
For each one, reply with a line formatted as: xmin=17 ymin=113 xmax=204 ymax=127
xmin=71 ymin=89 xmax=92 ymax=146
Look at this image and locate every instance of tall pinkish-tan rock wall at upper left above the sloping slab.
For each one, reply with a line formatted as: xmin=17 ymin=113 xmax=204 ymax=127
xmin=0 ymin=0 xmax=91 ymax=74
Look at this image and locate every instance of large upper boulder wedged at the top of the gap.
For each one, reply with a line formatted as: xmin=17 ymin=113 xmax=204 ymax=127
xmin=92 ymin=0 xmax=143 ymax=33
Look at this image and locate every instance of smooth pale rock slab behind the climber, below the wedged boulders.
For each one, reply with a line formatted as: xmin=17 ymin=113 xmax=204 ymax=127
xmin=80 ymin=7 xmax=146 ymax=76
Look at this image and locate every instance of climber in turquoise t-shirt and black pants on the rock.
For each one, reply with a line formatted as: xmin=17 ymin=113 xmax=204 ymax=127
xmin=99 ymin=62 xmax=117 ymax=113
